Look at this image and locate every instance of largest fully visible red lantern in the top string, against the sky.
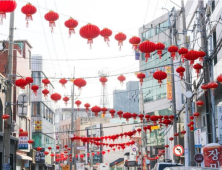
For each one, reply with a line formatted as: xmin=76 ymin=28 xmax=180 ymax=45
xmin=79 ymin=24 xmax=100 ymax=49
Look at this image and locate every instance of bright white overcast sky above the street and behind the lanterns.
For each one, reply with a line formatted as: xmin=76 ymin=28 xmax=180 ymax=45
xmin=0 ymin=0 xmax=184 ymax=107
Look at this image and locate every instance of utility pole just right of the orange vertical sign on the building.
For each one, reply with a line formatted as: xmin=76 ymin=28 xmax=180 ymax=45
xmin=168 ymin=9 xmax=179 ymax=163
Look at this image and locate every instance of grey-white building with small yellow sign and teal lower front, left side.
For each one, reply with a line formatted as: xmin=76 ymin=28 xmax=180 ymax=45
xmin=31 ymin=55 xmax=55 ymax=170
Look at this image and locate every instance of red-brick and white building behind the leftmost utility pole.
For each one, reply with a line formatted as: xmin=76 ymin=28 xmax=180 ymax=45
xmin=0 ymin=40 xmax=34 ymax=169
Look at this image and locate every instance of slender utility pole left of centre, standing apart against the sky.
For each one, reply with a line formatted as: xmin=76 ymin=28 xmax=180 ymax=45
xmin=69 ymin=67 xmax=76 ymax=170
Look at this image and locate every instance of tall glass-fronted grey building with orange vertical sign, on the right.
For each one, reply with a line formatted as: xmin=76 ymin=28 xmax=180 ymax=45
xmin=139 ymin=11 xmax=183 ymax=167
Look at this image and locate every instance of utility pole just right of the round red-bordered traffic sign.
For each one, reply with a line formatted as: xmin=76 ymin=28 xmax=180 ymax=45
xmin=181 ymin=0 xmax=195 ymax=166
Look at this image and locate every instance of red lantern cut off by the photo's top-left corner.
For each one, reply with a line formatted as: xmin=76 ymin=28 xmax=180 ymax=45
xmin=0 ymin=0 xmax=17 ymax=24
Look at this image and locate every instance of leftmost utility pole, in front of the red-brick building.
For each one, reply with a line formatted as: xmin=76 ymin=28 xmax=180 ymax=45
xmin=2 ymin=12 xmax=14 ymax=169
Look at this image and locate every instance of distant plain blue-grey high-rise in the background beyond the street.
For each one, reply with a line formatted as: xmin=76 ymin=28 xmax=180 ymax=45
xmin=113 ymin=81 xmax=139 ymax=113
